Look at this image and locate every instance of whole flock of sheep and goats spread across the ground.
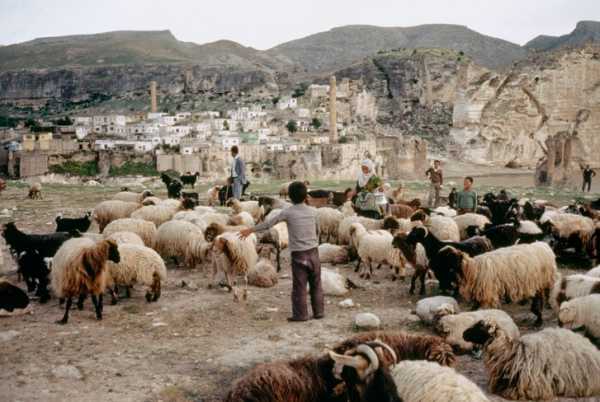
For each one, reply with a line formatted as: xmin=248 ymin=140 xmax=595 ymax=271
xmin=0 ymin=181 xmax=600 ymax=402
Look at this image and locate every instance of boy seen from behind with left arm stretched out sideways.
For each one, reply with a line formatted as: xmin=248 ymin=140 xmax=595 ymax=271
xmin=240 ymin=181 xmax=325 ymax=321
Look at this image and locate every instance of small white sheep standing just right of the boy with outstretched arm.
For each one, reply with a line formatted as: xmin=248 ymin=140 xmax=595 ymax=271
xmin=350 ymin=223 xmax=404 ymax=279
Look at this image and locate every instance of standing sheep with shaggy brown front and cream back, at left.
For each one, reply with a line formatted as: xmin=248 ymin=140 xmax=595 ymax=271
xmin=50 ymin=238 xmax=120 ymax=324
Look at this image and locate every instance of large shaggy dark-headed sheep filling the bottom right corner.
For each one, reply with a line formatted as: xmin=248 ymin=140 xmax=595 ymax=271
xmin=463 ymin=320 xmax=600 ymax=400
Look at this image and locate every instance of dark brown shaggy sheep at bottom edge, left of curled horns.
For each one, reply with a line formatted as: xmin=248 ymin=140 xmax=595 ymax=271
xmin=224 ymin=354 xmax=347 ymax=402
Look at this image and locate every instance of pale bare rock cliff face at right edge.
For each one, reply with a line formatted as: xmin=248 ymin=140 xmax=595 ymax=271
xmin=452 ymin=46 xmax=600 ymax=170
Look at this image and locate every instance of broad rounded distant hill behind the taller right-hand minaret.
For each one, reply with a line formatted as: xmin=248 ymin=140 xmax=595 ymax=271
xmin=268 ymin=24 xmax=526 ymax=71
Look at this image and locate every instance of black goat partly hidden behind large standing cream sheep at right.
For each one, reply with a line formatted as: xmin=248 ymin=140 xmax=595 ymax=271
xmin=406 ymin=227 xmax=492 ymax=292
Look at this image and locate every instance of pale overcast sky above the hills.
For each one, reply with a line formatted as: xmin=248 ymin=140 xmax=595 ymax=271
xmin=0 ymin=0 xmax=600 ymax=49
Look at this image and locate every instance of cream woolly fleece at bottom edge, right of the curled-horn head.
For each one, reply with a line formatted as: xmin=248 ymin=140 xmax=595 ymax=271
xmin=391 ymin=360 xmax=489 ymax=402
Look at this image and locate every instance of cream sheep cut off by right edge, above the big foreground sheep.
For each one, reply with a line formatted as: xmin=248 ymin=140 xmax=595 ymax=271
xmin=558 ymin=294 xmax=600 ymax=340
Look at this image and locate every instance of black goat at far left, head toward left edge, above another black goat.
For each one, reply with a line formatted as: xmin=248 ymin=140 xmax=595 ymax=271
xmin=2 ymin=222 xmax=81 ymax=258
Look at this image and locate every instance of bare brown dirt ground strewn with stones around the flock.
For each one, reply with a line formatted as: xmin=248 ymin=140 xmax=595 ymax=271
xmin=0 ymin=180 xmax=600 ymax=402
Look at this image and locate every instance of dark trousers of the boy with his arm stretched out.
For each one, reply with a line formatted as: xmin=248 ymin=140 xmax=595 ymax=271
xmin=292 ymin=248 xmax=325 ymax=320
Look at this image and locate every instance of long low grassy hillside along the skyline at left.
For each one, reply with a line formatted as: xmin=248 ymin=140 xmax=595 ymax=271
xmin=0 ymin=31 xmax=292 ymax=71
